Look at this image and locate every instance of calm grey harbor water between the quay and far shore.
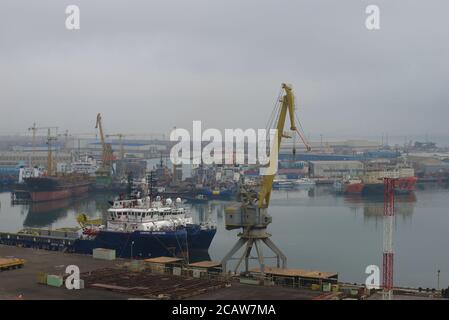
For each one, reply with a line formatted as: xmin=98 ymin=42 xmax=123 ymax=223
xmin=0 ymin=184 xmax=449 ymax=288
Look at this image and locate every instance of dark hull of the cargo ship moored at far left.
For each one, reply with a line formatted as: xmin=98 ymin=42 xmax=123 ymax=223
xmin=24 ymin=174 xmax=92 ymax=202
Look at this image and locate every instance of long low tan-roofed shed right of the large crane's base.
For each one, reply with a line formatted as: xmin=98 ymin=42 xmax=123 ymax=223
xmin=250 ymin=267 xmax=338 ymax=287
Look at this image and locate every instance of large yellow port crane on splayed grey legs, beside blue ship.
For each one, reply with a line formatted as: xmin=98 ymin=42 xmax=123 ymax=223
xmin=221 ymin=83 xmax=311 ymax=276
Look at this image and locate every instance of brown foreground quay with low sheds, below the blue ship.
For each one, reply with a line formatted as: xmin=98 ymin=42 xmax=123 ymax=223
xmin=0 ymin=245 xmax=438 ymax=300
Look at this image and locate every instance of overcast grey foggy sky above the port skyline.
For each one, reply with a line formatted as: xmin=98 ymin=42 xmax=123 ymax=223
xmin=0 ymin=0 xmax=449 ymax=141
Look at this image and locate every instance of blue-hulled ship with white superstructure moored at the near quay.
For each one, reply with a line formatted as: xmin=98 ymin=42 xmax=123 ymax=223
xmin=0 ymin=197 xmax=216 ymax=259
